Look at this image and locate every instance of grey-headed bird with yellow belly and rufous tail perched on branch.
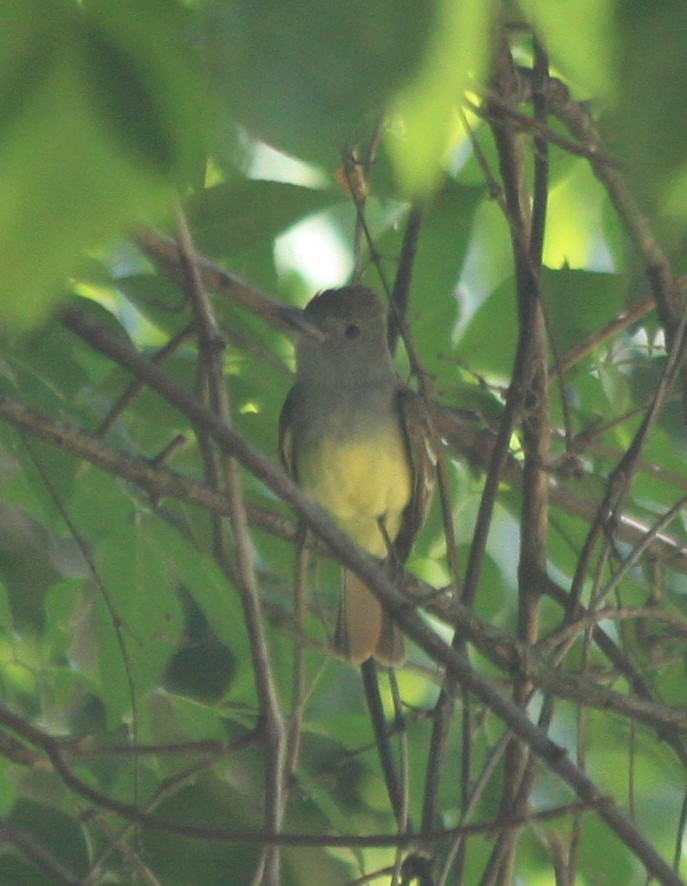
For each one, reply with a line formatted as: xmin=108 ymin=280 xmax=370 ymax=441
xmin=280 ymin=286 xmax=434 ymax=664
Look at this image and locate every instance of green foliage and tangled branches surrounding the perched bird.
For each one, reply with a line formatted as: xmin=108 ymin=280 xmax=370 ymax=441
xmin=0 ymin=0 xmax=687 ymax=886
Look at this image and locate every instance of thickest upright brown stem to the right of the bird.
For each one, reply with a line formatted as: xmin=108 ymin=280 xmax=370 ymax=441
xmin=482 ymin=35 xmax=550 ymax=886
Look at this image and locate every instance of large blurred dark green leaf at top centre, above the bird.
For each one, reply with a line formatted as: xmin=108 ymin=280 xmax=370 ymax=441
xmin=206 ymin=0 xmax=435 ymax=168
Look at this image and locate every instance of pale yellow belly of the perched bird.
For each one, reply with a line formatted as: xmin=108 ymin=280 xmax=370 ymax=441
xmin=298 ymin=427 xmax=412 ymax=557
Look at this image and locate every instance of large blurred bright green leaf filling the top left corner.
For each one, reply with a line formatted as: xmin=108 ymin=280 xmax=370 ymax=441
xmin=0 ymin=0 xmax=200 ymax=327
